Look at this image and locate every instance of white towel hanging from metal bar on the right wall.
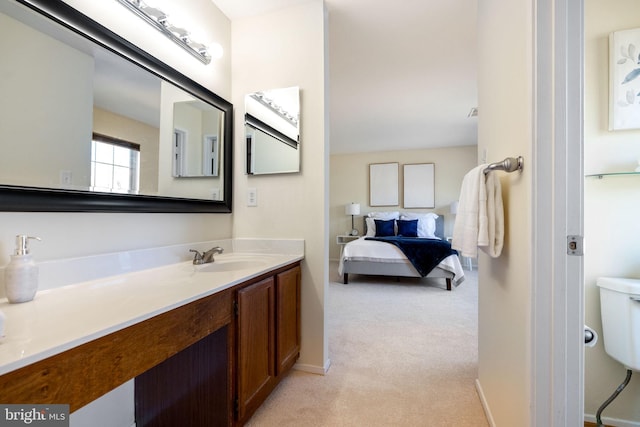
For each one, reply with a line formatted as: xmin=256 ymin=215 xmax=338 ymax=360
xmin=451 ymin=164 xmax=504 ymax=258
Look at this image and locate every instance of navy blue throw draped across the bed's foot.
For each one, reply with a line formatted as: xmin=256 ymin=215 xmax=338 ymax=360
xmin=365 ymin=236 xmax=458 ymax=277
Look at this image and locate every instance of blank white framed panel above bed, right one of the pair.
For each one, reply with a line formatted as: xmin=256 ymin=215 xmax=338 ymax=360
xmin=402 ymin=163 xmax=436 ymax=209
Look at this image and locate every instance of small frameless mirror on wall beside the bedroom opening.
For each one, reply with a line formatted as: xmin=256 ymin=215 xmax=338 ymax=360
xmin=245 ymin=87 xmax=300 ymax=175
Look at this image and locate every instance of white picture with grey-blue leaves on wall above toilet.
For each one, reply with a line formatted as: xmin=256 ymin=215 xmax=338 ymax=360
xmin=609 ymin=28 xmax=640 ymax=130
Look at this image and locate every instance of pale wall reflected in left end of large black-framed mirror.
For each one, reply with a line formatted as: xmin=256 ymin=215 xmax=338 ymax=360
xmin=0 ymin=10 xmax=94 ymax=188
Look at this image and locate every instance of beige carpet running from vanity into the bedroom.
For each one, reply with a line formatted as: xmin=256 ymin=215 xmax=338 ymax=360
xmin=247 ymin=263 xmax=488 ymax=427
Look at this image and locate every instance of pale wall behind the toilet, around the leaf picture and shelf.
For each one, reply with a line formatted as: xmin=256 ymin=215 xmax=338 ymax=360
xmin=584 ymin=0 xmax=640 ymax=423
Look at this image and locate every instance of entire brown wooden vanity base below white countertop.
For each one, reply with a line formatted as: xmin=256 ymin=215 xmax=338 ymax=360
xmin=0 ymin=262 xmax=300 ymax=427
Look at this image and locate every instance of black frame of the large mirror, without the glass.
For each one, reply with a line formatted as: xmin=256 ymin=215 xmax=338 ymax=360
xmin=0 ymin=0 xmax=233 ymax=213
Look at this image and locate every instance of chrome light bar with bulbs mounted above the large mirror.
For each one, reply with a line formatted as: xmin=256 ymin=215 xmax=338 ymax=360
xmin=116 ymin=0 xmax=211 ymax=64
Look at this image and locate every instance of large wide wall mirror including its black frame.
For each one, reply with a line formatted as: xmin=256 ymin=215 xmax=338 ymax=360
xmin=0 ymin=0 xmax=233 ymax=213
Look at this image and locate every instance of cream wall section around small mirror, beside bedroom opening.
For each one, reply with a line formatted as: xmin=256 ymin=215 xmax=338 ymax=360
xmin=232 ymin=0 xmax=329 ymax=372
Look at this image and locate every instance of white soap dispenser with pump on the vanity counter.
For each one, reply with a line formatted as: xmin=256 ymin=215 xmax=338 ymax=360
xmin=4 ymin=234 xmax=40 ymax=304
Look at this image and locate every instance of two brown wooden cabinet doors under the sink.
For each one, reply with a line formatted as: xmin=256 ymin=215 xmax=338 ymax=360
xmin=236 ymin=264 xmax=300 ymax=425
